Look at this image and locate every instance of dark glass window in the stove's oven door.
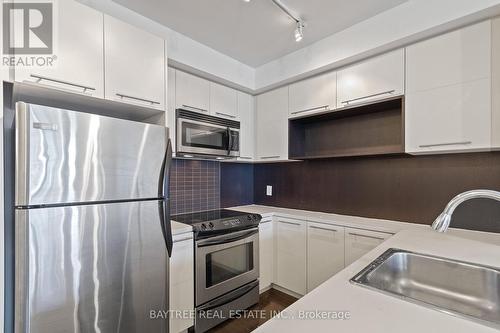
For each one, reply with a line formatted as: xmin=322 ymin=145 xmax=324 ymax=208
xmin=206 ymin=243 xmax=253 ymax=288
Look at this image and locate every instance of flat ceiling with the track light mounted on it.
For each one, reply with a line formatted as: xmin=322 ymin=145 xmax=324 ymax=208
xmin=113 ymin=0 xmax=407 ymax=67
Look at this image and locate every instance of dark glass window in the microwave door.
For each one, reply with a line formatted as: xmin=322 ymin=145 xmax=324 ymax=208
xmin=182 ymin=122 xmax=229 ymax=150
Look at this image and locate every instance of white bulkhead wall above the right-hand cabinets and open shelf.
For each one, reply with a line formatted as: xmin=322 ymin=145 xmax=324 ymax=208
xmin=255 ymin=0 xmax=500 ymax=90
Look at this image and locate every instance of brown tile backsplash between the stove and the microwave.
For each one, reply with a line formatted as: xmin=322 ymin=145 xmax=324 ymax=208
xmin=170 ymin=159 xmax=220 ymax=215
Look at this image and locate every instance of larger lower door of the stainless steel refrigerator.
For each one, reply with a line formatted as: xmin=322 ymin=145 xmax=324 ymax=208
xmin=15 ymin=200 xmax=169 ymax=333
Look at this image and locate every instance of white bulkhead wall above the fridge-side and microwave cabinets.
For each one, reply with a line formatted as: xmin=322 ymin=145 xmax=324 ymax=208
xmin=77 ymin=0 xmax=255 ymax=91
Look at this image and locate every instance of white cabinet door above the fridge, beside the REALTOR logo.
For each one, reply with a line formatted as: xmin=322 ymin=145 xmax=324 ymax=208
xmin=15 ymin=0 xmax=104 ymax=98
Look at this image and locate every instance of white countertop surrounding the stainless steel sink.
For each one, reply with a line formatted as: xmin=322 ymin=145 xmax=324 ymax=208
xmin=254 ymin=229 xmax=500 ymax=333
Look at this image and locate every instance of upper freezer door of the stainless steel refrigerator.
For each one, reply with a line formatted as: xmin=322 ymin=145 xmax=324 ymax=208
xmin=15 ymin=102 xmax=168 ymax=206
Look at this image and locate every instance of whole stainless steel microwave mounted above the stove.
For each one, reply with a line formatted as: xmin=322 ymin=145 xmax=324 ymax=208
xmin=176 ymin=109 xmax=240 ymax=158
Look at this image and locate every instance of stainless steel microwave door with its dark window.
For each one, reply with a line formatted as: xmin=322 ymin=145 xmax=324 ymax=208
xmin=177 ymin=118 xmax=232 ymax=156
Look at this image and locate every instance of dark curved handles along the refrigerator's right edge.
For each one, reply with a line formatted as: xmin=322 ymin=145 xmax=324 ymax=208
xmin=158 ymin=139 xmax=173 ymax=257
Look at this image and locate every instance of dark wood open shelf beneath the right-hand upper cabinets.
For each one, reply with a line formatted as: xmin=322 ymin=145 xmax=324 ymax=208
xmin=288 ymin=97 xmax=404 ymax=160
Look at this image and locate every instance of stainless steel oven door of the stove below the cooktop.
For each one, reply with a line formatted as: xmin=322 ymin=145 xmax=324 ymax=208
xmin=195 ymin=228 xmax=259 ymax=306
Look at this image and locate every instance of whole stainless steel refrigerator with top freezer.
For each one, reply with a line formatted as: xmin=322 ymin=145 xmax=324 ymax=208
xmin=14 ymin=102 xmax=172 ymax=333
